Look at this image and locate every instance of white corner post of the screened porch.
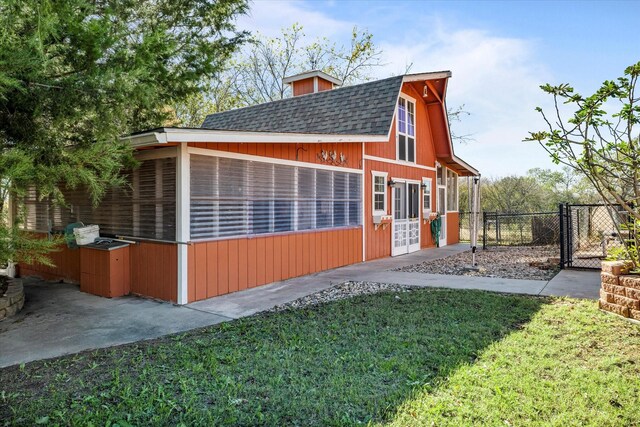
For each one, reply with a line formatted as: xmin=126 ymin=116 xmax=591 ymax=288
xmin=176 ymin=142 xmax=191 ymax=305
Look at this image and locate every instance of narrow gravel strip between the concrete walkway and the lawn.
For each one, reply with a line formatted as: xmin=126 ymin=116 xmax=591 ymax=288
xmin=268 ymin=282 xmax=414 ymax=311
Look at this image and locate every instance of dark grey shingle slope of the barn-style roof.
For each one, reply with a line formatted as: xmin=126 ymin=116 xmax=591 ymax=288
xmin=202 ymin=76 xmax=403 ymax=135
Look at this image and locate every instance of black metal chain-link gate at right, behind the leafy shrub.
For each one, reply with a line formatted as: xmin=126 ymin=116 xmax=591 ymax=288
xmin=559 ymin=204 xmax=628 ymax=269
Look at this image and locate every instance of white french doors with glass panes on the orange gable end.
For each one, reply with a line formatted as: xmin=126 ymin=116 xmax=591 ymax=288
xmin=391 ymin=182 xmax=420 ymax=256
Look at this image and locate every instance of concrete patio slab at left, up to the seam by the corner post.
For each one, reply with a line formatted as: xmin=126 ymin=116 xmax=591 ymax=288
xmin=0 ymin=278 xmax=230 ymax=368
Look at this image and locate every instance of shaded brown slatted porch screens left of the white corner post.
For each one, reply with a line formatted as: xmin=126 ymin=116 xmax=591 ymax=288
xmin=23 ymin=158 xmax=176 ymax=241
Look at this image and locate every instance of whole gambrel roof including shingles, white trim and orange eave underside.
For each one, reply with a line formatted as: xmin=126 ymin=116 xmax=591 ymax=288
xmin=123 ymin=71 xmax=479 ymax=175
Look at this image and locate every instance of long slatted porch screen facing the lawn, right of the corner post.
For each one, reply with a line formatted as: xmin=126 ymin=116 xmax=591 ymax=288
xmin=190 ymin=155 xmax=362 ymax=240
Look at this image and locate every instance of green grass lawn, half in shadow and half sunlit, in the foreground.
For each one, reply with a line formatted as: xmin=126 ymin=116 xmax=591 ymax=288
xmin=0 ymin=289 xmax=640 ymax=426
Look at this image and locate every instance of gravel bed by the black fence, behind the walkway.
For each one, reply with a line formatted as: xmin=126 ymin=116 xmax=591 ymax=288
xmin=393 ymin=246 xmax=560 ymax=280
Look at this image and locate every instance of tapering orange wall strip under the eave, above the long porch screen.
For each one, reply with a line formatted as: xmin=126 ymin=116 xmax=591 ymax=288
xmin=189 ymin=142 xmax=362 ymax=169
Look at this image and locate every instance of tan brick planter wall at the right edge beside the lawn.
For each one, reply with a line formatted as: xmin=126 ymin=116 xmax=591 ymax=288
xmin=599 ymin=261 xmax=640 ymax=321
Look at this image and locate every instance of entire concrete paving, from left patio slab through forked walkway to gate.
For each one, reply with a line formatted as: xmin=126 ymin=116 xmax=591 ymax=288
xmin=0 ymin=244 xmax=600 ymax=368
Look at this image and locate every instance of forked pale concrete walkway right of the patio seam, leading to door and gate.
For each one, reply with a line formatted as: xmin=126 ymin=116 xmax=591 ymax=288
xmin=187 ymin=244 xmax=600 ymax=318
